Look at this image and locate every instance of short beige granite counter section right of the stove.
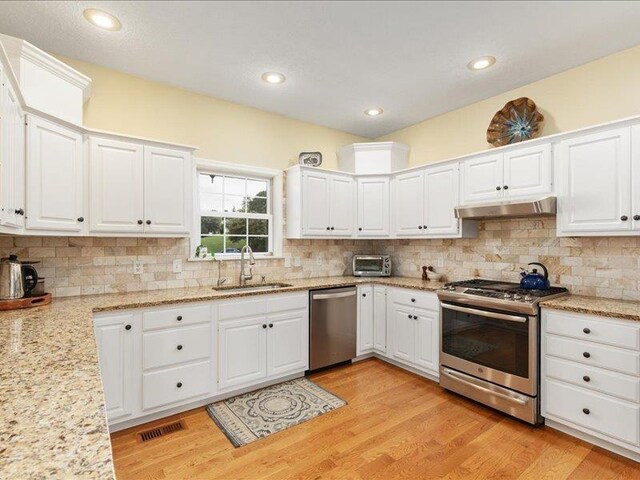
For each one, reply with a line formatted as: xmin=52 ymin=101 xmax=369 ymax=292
xmin=540 ymin=295 xmax=640 ymax=322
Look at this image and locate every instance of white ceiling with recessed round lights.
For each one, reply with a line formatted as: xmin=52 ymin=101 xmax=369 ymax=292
xmin=0 ymin=1 xmax=640 ymax=138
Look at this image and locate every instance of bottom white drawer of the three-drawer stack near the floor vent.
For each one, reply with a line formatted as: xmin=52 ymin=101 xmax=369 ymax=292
xmin=142 ymin=361 xmax=212 ymax=410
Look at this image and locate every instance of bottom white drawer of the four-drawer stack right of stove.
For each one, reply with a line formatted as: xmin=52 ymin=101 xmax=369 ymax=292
xmin=544 ymin=379 xmax=640 ymax=445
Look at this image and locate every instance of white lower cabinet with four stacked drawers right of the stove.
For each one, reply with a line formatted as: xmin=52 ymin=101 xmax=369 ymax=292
xmin=541 ymin=309 xmax=640 ymax=460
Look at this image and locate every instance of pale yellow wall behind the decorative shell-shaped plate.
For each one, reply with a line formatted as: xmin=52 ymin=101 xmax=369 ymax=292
xmin=376 ymin=46 xmax=640 ymax=165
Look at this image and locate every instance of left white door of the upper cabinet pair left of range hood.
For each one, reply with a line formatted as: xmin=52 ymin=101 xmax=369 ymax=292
xmin=392 ymin=171 xmax=424 ymax=236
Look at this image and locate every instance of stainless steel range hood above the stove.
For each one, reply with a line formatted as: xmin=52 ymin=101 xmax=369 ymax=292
xmin=455 ymin=197 xmax=556 ymax=220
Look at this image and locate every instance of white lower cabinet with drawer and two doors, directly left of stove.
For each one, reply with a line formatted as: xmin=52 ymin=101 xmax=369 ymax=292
xmin=387 ymin=288 xmax=440 ymax=376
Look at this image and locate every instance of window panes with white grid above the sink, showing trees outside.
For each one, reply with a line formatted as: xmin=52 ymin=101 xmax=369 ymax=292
xmin=198 ymin=172 xmax=273 ymax=254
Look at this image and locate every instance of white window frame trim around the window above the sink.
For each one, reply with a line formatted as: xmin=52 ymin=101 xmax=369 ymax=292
xmin=191 ymin=158 xmax=284 ymax=260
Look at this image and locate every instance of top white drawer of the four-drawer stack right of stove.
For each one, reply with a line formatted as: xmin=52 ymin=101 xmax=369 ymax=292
xmin=546 ymin=311 xmax=640 ymax=350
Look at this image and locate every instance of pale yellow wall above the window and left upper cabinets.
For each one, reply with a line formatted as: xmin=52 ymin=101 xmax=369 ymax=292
xmin=59 ymin=57 xmax=366 ymax=169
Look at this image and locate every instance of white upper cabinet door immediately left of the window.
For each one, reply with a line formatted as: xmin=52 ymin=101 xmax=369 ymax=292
xmin=144 ymin=146 xmax=194 ymax=235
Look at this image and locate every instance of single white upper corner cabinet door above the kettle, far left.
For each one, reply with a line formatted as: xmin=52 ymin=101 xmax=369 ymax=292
xmin=27 ymin=116 xmax=84 ymax=232
